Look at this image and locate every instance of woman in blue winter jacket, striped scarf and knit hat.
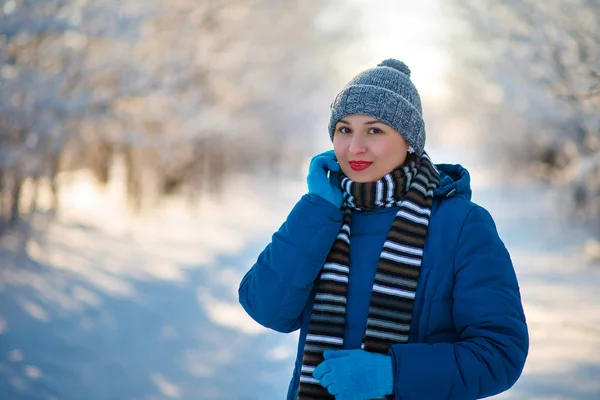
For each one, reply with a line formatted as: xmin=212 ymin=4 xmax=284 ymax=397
xmin=239 ymin=60 xmax=529 ymax=400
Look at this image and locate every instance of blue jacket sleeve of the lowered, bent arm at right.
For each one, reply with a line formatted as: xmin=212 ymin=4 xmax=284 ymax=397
xmin=390 ymin=206 xmax=529 ymax=400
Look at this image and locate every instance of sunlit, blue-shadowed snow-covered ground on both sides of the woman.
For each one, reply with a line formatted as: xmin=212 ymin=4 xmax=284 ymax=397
xmin=0 ymin=148 xmax=600 ymax=400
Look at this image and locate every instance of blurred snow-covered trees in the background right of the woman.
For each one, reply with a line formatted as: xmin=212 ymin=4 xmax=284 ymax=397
xmin=452 ymin=0 xmax=600 ymax=231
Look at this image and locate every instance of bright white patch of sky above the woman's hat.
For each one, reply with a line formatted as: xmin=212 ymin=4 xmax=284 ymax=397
xmin=344 ymin=0 xmax=453 ymax=102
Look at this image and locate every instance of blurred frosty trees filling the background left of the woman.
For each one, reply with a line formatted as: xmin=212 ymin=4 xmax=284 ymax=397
xmin=0 ymin=0 xmax=348 ymax=234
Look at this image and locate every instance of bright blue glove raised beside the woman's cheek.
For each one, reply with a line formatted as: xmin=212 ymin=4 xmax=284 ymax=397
xmin=306 ymin=150 xmax=342 ymax=208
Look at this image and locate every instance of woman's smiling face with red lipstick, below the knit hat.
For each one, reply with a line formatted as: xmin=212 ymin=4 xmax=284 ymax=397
xmin=333 ymin=114 xmax=409 ymax=183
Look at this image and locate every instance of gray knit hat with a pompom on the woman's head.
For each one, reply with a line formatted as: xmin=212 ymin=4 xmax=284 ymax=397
xmin=329 ymin=58 xmax=425 ymax=155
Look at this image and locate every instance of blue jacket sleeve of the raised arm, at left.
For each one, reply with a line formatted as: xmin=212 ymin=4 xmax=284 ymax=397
xmin=238 ymin=194 xmax=342 ymax=333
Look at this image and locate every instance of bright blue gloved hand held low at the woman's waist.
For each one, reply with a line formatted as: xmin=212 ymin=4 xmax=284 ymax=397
xmin=313 ymin=349 xmax=394 ymax=400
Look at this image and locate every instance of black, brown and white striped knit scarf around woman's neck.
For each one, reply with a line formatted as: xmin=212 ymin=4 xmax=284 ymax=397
xmin=298 ymin=153 xmax=440 ymax=400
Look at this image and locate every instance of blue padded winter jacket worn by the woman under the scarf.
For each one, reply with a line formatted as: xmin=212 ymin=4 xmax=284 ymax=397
xmin=239 ymin=164 xmax=529 ymax=400
